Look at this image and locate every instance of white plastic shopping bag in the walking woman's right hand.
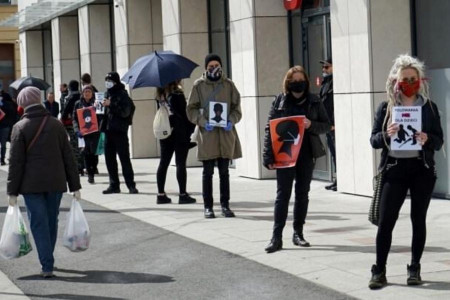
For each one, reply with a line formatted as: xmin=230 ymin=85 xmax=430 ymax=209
xmin=63 ymin=198 xmax=91 ymax=252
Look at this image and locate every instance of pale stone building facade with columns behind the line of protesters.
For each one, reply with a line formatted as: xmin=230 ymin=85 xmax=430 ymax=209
xmin=1 ymin=0 xmax=450 ymax=197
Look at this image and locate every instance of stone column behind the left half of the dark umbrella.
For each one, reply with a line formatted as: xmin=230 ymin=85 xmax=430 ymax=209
xmin=114 ymin=0 xmax=163 ymax=158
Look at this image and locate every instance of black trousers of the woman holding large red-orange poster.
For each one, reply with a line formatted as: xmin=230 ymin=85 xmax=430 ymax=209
xmin=273 ymin=149 xmax=314 ymax=239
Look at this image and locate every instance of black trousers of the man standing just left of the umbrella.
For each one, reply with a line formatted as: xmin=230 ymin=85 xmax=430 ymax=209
xmin=105 ymin=131 xmax=136 ymax=188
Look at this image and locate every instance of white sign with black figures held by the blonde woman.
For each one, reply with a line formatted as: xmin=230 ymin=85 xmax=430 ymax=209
xmin=391 ymin=106 xmax=422 ymax=151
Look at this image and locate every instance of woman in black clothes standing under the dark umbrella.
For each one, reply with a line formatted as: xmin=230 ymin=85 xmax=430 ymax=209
xmin=156 ymin=81 xmax=196 ymax=204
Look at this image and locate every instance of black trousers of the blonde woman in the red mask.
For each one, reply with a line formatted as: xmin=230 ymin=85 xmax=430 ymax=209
xmin=376 ymin=158 xmax=436 ymax=268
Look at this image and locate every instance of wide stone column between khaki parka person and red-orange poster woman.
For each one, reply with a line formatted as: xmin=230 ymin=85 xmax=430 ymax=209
xmin=229 ymin=0 xmax=289 ymax=179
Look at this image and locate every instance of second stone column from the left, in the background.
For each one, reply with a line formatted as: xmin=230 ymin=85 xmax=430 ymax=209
xmin=51 ymin=16 xmax=81 ymax=99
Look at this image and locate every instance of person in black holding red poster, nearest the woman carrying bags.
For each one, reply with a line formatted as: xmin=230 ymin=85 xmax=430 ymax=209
xmin=73 ymin=85 xmax=100 ymax=183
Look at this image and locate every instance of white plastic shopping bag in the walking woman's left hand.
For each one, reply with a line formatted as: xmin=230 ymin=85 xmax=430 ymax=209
xmin=0 ymin=204 xmax=33 ymax=259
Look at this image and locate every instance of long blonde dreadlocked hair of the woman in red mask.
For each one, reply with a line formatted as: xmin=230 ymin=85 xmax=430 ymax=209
xmin=382 ymin=54 xmax=431 ymax=145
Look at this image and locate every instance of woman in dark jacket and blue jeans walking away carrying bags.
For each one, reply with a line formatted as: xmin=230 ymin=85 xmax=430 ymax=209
xmin=7 ymin=87 xmax=81 ymax=278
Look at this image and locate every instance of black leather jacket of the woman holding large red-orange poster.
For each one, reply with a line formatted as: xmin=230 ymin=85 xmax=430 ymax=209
xmin=263 ymin=93 xmax=331 ymax=167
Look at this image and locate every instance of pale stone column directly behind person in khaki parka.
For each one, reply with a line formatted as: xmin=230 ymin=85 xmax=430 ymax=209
xmin=162 ymin=0 xmax=209 ymax=166
